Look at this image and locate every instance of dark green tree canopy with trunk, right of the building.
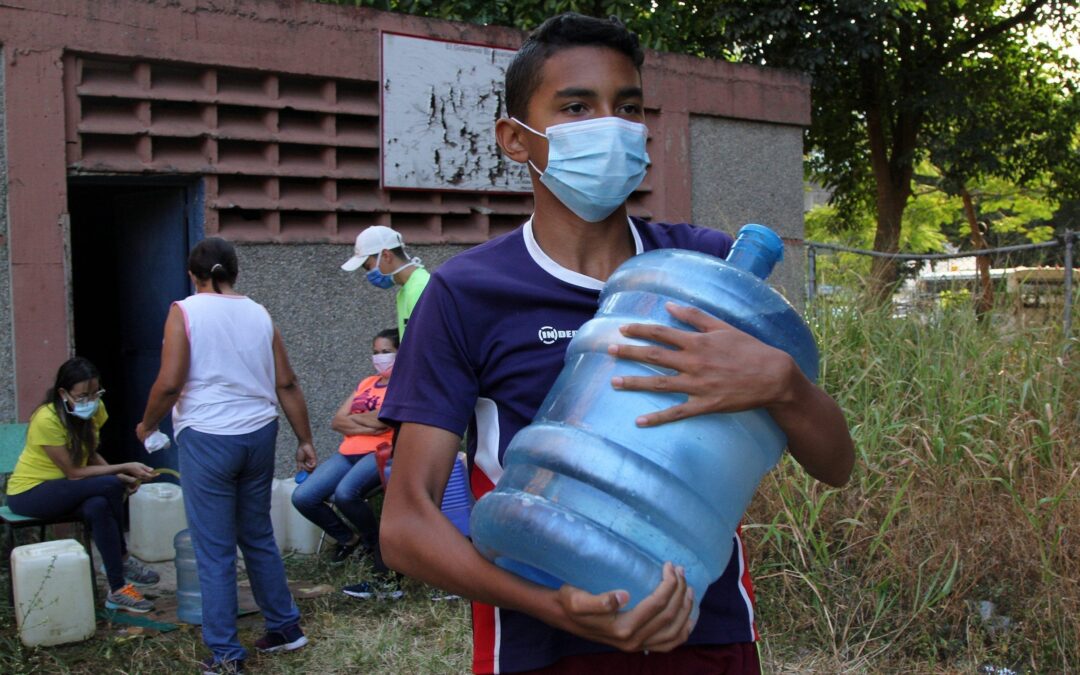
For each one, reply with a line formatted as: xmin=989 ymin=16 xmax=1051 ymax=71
xmin=719 ymin=0 xmax=1080 ymax=297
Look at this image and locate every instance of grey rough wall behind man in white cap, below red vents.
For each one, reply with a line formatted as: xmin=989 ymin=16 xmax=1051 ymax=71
xmin=237 ymin=244 xmax=465 ymax=477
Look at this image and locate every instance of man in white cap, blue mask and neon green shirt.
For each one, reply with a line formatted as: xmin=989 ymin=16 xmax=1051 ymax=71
xmin=341 ymin=225 xmax=431 ymax=339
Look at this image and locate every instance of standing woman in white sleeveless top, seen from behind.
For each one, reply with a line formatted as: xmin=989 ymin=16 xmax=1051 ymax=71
xmin=135 ymin=238 xmax=316 ymax=672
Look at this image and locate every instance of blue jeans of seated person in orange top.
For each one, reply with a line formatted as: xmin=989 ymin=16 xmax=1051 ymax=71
xmin=293 ymin=453 xmax=379 ymax=548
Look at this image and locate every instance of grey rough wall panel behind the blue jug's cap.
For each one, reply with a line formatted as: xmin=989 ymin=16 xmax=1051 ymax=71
xmin=690 ymin=116 xmax=806 ymax=310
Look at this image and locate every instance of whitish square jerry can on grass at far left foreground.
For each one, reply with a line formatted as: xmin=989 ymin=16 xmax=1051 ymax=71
xmin=11 ymin=539 xmax=95 ymax=647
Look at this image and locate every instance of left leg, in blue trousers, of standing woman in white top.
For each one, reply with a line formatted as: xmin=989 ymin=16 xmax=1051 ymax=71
xmin=176 ymin=429 xmax=248 ymax=662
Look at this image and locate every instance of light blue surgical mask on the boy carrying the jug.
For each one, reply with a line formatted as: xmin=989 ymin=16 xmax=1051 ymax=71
xmin=511 ymin=117 xmax=649 ymax=222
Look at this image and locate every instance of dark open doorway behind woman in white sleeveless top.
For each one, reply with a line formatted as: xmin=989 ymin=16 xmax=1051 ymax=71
xmin=68 ymin=177 xmax=203 ymax=477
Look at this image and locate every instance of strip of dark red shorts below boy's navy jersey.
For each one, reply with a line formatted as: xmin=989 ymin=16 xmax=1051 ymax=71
xmin=511 ymin=643 xmax=761 ymax=675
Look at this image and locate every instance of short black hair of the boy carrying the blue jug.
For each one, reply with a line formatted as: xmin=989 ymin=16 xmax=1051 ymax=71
xmin=505 ymin=12 xmax=645 ymax=120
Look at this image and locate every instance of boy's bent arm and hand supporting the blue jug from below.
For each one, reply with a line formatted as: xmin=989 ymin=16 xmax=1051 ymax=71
xmin=379 ymin=423 xmax=693 ymax=651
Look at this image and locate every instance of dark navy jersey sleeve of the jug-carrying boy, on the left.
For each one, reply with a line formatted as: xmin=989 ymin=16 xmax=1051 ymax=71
xmin=379 ymin=273 xmax=480 ymax=435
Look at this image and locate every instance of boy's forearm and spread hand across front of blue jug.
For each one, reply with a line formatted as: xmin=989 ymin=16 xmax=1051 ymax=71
xmin=609 ymin=303 xmax=855 ymax=486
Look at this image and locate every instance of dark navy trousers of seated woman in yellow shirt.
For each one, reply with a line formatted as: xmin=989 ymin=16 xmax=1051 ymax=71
xmin=8 ymin=475 xmax=127 ymax=591
